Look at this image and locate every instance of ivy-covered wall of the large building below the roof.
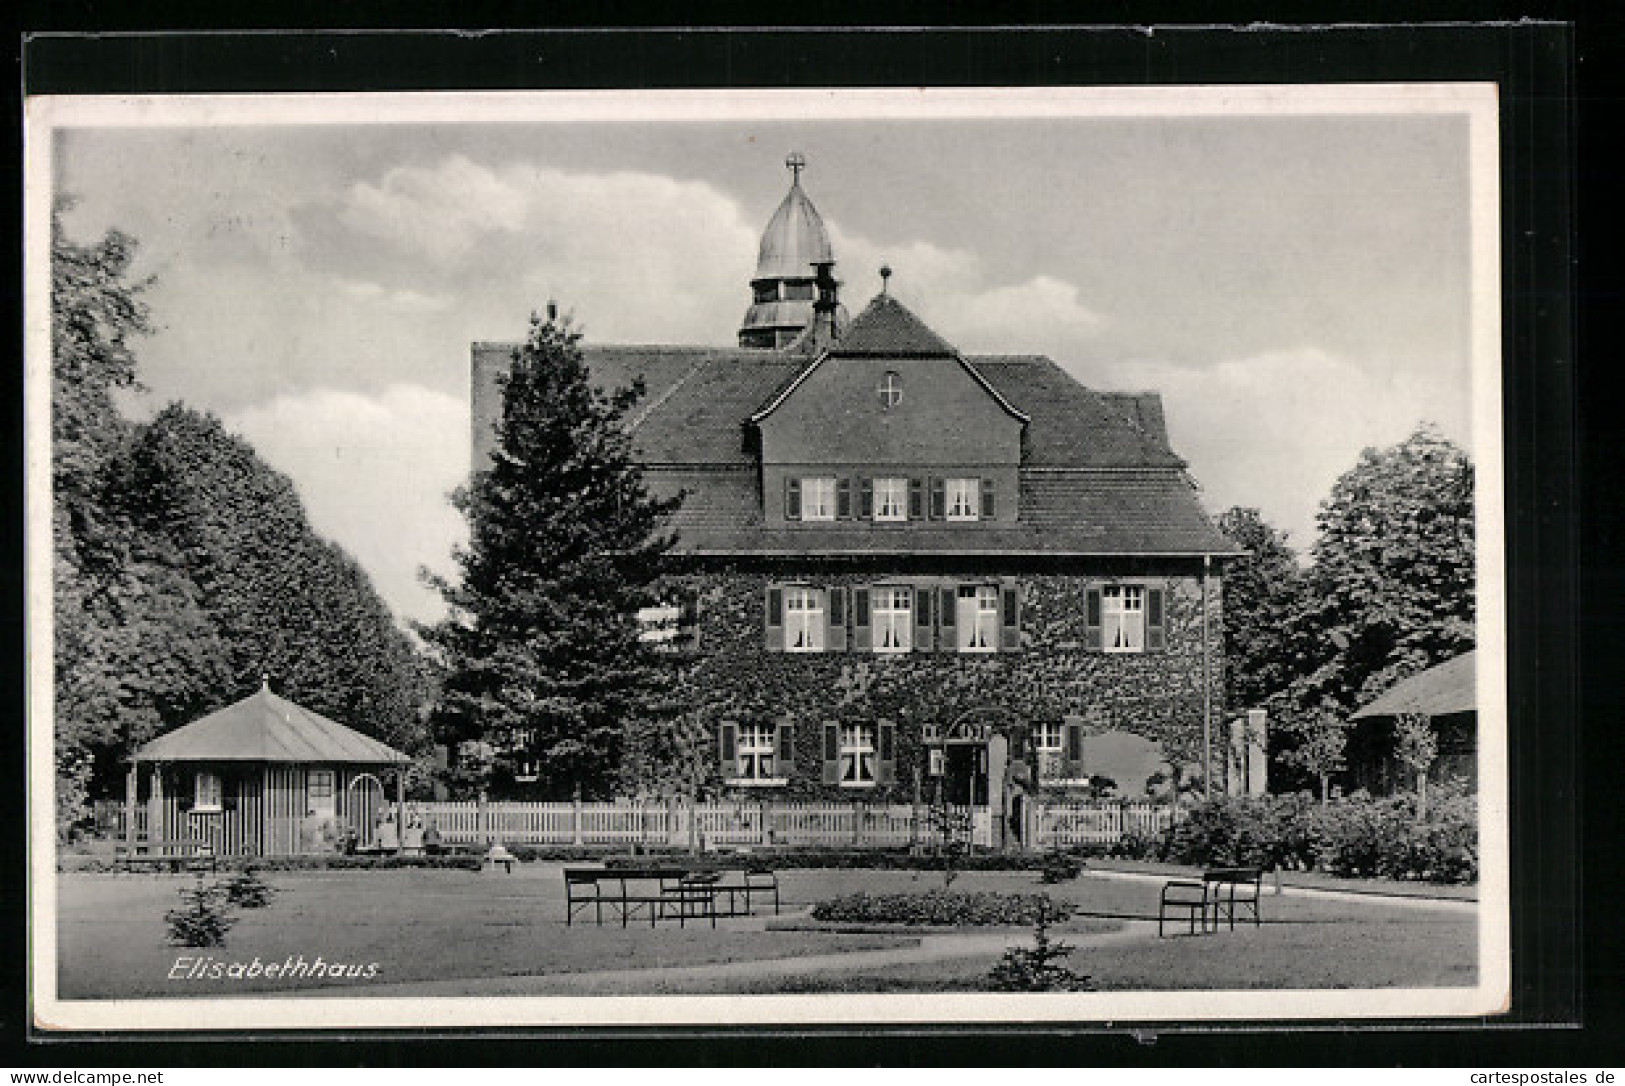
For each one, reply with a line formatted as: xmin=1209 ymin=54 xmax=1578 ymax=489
xmin=627 ymin=559 xmax=1224 ymax=803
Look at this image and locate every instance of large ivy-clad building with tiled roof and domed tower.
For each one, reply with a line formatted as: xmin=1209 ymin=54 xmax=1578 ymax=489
xmin=473 ymin=156 xmax=1233 ymax=838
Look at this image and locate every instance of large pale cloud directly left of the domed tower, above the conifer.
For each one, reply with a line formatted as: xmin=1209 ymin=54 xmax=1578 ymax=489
xmin=333 ymin=154 xmax=765 ymax=343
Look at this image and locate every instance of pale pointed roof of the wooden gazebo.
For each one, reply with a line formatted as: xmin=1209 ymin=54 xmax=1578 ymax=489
xmin=133 ymin=684 xmax=411 ymax=766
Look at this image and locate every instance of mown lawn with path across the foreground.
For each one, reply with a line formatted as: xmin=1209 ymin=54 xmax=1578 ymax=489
xmin=59 ymin=863 xmax=1476 ymax=998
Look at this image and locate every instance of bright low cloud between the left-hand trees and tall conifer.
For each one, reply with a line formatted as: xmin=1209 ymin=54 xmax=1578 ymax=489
xmin=226 ymin=384 xmax=468 ymax=621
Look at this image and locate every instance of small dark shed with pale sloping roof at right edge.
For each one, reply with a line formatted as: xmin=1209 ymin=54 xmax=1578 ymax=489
xmin=1347 ymin=652 xmax=1479 ymax=793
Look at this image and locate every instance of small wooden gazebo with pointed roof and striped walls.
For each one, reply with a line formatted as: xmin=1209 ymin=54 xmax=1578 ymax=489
xmin=125 ymin=684 xmax=411 ymax=855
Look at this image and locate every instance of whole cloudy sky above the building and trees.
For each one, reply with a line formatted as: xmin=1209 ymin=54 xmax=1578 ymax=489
xmin=44 ymin=91 xmax=1474 ymax=619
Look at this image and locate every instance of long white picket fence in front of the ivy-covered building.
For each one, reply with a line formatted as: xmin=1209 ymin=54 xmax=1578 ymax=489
xmin=406 ymin=800 xmax=1173 ymax=849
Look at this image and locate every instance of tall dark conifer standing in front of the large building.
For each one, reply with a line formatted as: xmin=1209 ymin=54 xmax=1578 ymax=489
xmin=424 ymin=306 xmax=679 ymax=798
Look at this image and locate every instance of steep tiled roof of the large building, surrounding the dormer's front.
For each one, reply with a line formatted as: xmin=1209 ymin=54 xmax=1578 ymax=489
xmin=473 ymin=308 xmax=1237 ymax=554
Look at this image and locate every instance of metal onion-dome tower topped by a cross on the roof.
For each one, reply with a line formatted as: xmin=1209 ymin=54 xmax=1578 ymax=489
xmin=739 ymin=151 xmax=847 ymax=350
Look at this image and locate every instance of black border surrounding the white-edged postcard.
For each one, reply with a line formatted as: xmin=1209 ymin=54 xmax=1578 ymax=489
xmin=9 ymin=14 xmax=1586 ymax=1066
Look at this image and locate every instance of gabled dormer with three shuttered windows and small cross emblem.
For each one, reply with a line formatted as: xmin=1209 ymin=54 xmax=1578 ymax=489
xmin=749 ymin=293 xmax=1027 ymax=527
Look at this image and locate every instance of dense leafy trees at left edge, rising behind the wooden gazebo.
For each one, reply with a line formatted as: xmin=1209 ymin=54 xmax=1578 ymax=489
xmin=50 ymin=205 xmax=426 ymax=824
